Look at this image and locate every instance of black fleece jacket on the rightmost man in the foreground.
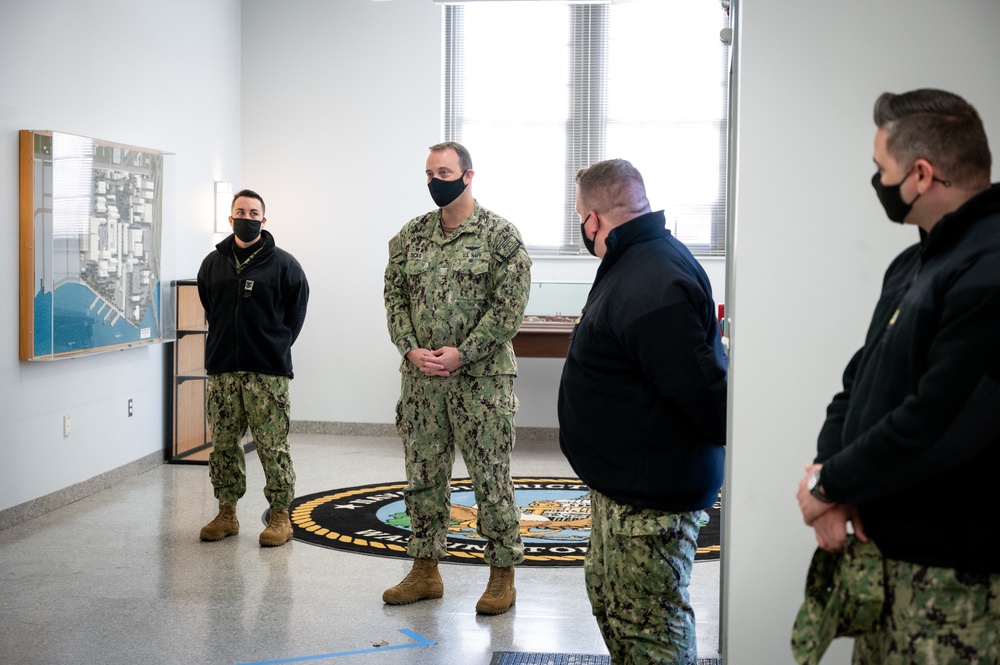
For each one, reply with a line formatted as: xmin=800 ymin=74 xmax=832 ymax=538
xmin=816 ymin=185 xmax=1000 ymax=573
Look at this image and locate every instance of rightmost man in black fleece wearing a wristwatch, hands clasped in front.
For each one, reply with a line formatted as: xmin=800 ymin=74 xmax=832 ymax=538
xmin=797 ymin=89 xmax=1000 ymax=664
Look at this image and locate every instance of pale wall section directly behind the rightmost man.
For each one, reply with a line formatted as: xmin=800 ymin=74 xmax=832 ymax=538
xmin=723 ymin=0 xmax=1000 ymax=665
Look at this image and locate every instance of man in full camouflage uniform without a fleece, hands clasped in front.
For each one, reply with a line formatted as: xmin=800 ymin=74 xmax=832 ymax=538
xmin=382 ymin=142 xmax=531 ymax=614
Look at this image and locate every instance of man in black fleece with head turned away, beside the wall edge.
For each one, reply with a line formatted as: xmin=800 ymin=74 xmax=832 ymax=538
xmin=558 ymin=159 xmax=726 ymax=665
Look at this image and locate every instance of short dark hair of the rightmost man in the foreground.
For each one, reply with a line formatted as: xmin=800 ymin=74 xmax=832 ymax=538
xmin=874 ymin=88 xmax=992 ymax=187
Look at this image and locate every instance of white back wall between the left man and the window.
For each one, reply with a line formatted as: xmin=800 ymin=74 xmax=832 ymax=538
xmin=240 ymin=0 xmax=442 ymax=423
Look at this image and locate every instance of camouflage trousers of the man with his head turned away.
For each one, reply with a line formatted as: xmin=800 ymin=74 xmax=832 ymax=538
xmin=583 ymin=490 xmax=706 ymax=665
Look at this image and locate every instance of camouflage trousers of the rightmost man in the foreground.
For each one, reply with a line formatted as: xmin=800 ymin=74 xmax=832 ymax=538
xmin=852 ymin=559 xmax=1000 ymax=665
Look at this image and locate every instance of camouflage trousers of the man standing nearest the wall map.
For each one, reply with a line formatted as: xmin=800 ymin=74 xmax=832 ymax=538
xmin=207 ymin=372 xmax=295 ymax=510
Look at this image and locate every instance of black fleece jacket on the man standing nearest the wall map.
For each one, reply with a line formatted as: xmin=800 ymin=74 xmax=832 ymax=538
xmin=198 ymin=231 xmax=309 ymax=378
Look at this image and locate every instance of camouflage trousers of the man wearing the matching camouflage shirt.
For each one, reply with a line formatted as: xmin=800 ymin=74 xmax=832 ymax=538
xmin=396 ymin=372 xmax=524 ymax=567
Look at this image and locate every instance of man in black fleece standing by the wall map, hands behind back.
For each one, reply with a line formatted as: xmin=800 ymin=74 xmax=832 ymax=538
xmin=198 ymin=189 xmax=309 ymax=547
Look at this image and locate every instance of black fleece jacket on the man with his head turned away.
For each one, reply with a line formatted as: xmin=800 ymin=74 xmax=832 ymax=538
xmin=558 ymin=211 xmax=726 ymax=512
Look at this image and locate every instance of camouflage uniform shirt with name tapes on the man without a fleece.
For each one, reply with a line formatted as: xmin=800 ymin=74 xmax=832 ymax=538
xmin=384 ymin=202 xmax=531 ymax=376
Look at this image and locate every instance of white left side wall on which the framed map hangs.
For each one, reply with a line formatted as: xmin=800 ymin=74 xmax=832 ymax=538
xmin=0 ymin=0 xmax=240 ymax=510
